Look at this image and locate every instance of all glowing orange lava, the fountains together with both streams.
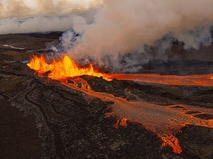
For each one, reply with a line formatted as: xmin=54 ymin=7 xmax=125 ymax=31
xmin=27 ymin=55 xmax=213 ymax=153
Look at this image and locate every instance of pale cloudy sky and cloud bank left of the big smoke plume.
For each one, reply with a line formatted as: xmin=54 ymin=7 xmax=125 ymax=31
xmin=0 ymin=0 xmax=103 ymax=34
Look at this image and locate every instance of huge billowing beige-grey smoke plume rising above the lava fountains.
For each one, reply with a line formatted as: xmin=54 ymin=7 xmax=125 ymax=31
xmin=57 ymin=0 xmax=213 ymax=71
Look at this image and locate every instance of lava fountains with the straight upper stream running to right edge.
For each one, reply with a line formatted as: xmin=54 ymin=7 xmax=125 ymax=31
xmin=27 ymin=55 xmax=213 ymax=86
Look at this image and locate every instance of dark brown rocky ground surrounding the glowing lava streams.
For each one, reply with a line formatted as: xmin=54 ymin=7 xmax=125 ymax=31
xmin=0 ymin=33 xmax=213 ymax=159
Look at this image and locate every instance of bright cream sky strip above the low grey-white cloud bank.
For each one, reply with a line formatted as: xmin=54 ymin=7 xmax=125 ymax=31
xmin=0 ymin=0 xmax=103 ymax=18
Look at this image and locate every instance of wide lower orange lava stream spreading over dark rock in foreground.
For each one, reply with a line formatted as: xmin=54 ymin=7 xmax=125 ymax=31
xmin=62 ymin=78 xmax=213 ymax=154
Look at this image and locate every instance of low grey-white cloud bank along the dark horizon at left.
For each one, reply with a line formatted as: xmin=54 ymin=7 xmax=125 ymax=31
xmin=0 ymin=9 xmax=96 ymax=34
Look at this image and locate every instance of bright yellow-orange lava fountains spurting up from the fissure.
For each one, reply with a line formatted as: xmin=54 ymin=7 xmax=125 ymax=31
xmin=27 ymin=55 xmax=110 ymax=80
